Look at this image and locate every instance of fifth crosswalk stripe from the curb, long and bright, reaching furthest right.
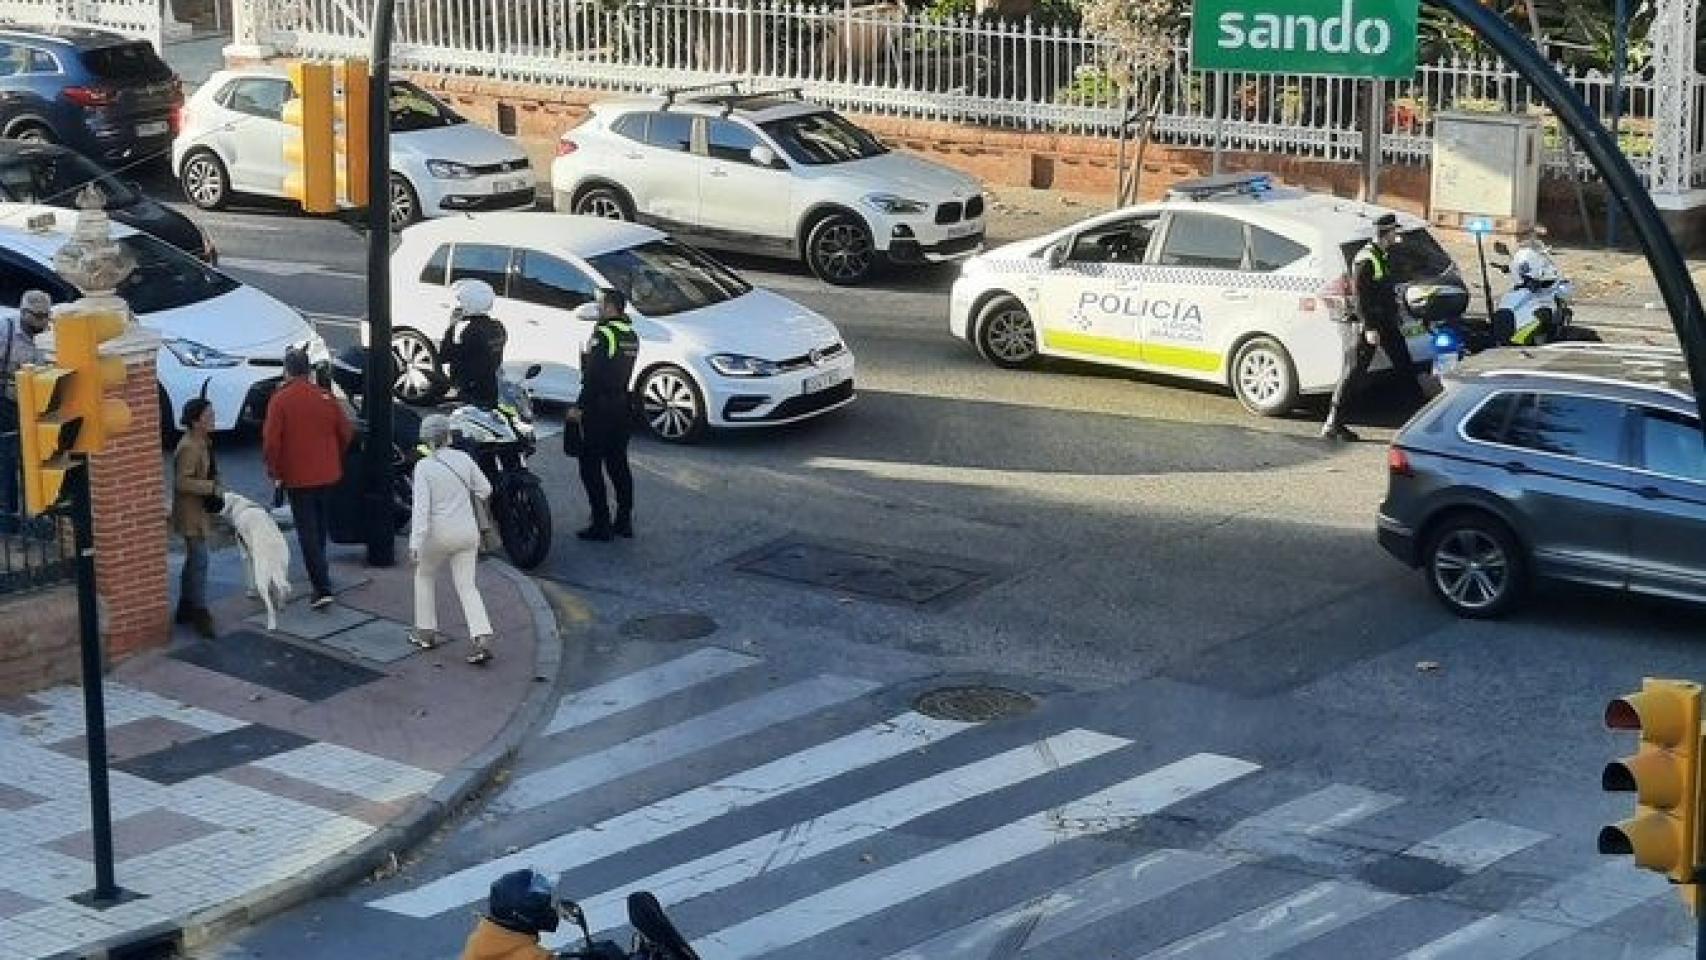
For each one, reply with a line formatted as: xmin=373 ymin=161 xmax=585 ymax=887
xmin=696 ymin=754 xmax=1261 ymax=960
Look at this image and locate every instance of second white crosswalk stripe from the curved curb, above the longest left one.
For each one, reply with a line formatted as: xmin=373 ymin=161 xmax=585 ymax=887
xmin=495 ymin=675 xmax=877 ymax=810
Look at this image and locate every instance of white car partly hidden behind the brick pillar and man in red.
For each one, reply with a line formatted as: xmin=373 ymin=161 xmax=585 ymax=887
xmin=0 ymin=203 xmax=329 ymax=430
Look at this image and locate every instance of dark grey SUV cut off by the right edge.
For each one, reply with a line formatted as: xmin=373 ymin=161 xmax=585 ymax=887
xmin=1380 ymin=344 xmax=1706 ymax=617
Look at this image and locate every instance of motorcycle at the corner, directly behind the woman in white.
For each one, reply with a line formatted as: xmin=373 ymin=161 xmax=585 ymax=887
xmin=331 ymin=346 xmax=551 ymax=570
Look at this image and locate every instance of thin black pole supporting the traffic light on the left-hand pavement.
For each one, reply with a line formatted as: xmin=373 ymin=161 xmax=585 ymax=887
xmin=67 ymin=457 xmax=119 ymax=905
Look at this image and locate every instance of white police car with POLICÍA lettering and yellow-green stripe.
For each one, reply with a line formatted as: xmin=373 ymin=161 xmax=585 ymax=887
xmin=949 ymin=174 xmax=1462 ymax=416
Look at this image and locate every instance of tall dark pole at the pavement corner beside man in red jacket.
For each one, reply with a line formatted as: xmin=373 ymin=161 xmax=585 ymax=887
xmin=362 ymin=0 xmax=397 ymax=566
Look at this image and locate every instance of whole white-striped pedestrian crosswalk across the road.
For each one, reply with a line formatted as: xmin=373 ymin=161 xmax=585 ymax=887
xmin=359 ymin=646 xmax=1682 ymax=960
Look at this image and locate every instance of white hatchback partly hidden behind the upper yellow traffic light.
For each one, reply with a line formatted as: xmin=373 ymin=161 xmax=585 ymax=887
xmin=172 ymin=68 xmax=536 ymax=228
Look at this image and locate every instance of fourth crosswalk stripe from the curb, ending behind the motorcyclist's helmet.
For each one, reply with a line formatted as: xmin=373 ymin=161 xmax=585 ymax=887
xmin=548 ymin=730 xmax=1131 ymax=946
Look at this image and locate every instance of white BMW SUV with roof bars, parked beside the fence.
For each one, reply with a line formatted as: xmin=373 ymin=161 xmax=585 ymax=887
xmin=551 ymin=89 xmax=984 ymax=285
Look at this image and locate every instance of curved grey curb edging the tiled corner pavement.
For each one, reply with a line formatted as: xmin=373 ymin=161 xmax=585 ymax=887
xmin=44 ymin=559 xmax=563 ymax=960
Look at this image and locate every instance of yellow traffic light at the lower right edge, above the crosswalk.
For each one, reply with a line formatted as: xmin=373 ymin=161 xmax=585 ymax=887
xmin=1599 ymin=677 xmax=1701 ymax=883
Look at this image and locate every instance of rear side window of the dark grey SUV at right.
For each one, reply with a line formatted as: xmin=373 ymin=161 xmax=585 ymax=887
xmin=1465 ymin=392 xmax=1628 ymax=466
